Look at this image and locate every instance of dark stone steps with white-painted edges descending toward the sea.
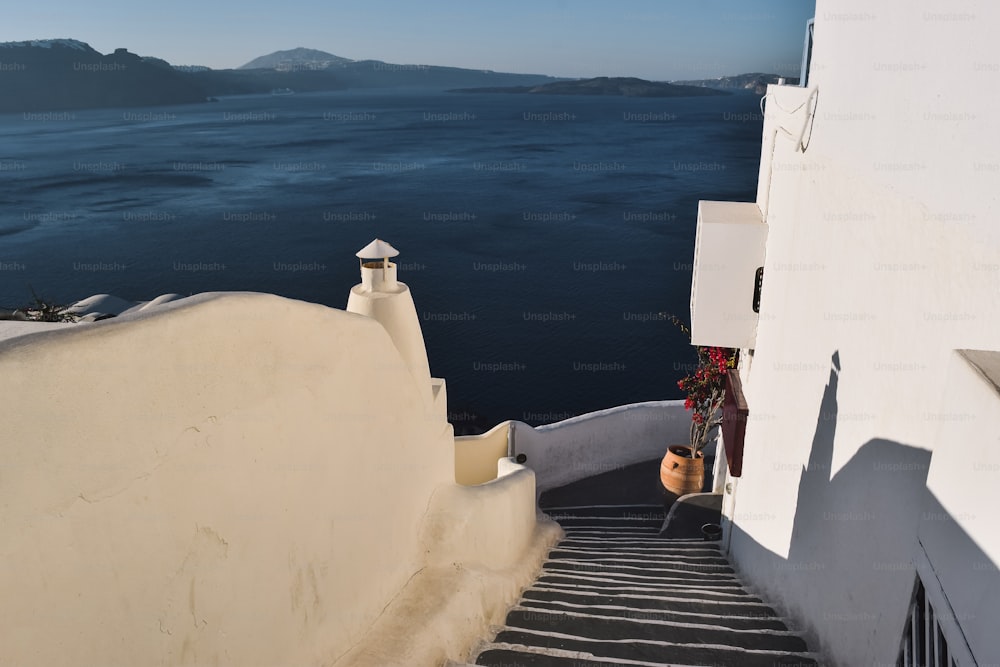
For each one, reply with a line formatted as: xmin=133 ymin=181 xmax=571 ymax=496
xmin=473 ymin=498 xmax=820 ymax=667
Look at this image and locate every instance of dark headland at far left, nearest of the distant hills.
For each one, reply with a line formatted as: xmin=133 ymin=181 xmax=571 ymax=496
xmin=0 ymin=39 xmax=206 ymax=112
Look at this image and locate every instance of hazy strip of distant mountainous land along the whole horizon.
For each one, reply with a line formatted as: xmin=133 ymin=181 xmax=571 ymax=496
xmin=0 ymin=39 xmax=795 ymax=113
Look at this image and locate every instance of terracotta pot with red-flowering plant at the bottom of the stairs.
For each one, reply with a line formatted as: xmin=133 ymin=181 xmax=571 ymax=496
xmin=660 ymin=316 xmax=738 ymax=496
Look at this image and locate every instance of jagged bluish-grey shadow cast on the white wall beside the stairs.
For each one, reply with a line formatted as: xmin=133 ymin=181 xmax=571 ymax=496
xmin=732 ymin=352 xmax=1000 ymax=665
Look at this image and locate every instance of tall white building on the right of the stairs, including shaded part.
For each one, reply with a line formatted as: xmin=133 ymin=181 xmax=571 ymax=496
xmin=692 ymin=0 xmax=1000 ymax=667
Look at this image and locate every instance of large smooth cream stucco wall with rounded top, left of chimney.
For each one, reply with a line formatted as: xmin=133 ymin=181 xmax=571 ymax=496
xmin=0 ymin=294 xmax=556 ymax=667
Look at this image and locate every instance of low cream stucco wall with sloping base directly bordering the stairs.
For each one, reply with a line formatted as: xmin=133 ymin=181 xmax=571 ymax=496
xmin=337 ymin=458 xmax=563 ymax=667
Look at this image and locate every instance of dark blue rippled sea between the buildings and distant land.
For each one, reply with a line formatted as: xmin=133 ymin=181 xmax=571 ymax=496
xmin=0 ymin=91 xmax=761 ymax=424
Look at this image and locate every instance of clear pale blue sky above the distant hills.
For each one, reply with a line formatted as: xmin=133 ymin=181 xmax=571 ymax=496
xmin=0 ymin=0 xmax=815 ymax=81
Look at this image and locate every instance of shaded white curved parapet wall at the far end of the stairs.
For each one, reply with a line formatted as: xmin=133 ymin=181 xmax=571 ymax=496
xmin=512 ymin=400 xmax=691 ymax=492
